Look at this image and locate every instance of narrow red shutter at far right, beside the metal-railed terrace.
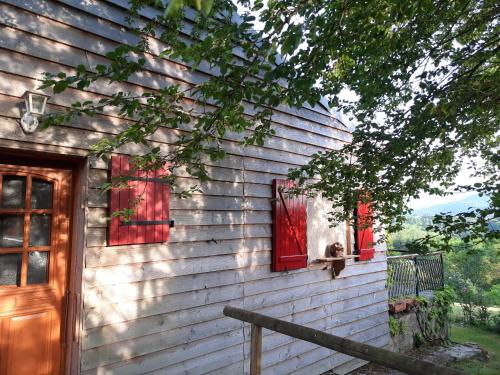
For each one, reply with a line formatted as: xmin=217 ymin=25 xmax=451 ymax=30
xmin=355 ymin=200 xmax=375 ymax=260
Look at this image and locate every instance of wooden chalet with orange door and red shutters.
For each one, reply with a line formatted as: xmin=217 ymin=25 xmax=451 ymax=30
xmin=0 ymin=0 xmax=389 ymax=375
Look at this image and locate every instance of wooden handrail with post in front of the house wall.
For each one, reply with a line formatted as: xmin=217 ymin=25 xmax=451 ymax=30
xmin=224 ymin=306 xmax=464 ymax=375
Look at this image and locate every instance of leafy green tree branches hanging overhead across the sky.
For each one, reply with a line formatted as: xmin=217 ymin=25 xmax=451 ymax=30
xmin=43 ymin=0 xmax=500 ymax=245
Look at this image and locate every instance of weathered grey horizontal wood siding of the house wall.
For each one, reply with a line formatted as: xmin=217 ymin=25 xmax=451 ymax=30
xmin=0 ymin=0 xmax=388 ymax=375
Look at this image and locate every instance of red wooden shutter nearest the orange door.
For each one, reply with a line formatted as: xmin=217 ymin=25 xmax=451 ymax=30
xmin=109 ymin=156 xmax=170 ymax=246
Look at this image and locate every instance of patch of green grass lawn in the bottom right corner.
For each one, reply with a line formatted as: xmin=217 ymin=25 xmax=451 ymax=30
xmin=450 ymin=325 xmax=500 ymax=375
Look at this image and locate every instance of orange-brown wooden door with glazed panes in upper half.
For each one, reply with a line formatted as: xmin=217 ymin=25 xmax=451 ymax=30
xmin=0 ymin=164 xmax=71 ymax=375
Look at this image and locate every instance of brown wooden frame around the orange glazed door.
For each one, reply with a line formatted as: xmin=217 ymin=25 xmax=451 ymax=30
xmin=0 ymin=145 xmax=89 ymax=375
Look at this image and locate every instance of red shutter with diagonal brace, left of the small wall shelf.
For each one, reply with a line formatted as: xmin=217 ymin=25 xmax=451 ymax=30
xmin=272 ymin=180 xmax=307 ymax=271
